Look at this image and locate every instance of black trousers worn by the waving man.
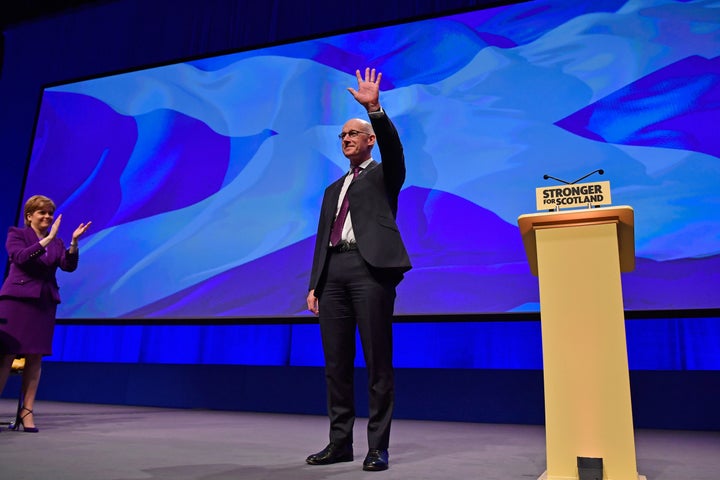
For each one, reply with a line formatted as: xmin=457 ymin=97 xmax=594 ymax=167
xmin=319 ymin=250 xmax=397 ymax=449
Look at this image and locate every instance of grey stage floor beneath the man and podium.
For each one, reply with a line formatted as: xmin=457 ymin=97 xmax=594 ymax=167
xmin=0 ymin=400 xmax=720 ymax=480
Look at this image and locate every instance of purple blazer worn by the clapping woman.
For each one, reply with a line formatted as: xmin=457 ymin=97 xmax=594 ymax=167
xmin=0 ymin=227 xmax=80 ymax=303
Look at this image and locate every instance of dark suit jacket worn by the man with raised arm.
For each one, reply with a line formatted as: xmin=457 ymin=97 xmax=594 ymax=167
xmin=309 ymin=110 xmax=411 ymax=297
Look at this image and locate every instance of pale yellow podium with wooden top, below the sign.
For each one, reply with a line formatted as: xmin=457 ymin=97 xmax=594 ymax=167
xmin=518 ymin=206 xmax=644 ymax=480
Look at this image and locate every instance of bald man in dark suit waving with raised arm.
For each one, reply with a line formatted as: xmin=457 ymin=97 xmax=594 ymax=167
xmin=307 ymin=68 xmax=411 ymax=471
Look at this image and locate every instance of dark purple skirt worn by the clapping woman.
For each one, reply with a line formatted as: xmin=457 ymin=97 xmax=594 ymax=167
xmin=0 ymin=289 xmax=57 ymax=355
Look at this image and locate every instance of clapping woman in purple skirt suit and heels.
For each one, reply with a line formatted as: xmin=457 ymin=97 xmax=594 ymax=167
xmin=0 ymin=195 xmax=91 ymax=432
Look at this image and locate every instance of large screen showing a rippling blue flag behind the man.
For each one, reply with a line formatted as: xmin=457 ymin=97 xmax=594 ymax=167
xmin=25 ymin=0 xmax=720 ymax=319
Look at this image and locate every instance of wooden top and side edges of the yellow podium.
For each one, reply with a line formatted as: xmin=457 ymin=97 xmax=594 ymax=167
xmin=518 ymin=205 xmax=635 ymax=275
